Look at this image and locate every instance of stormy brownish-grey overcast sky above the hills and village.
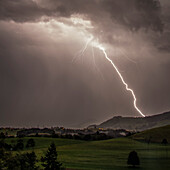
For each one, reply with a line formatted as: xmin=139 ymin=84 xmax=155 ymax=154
xmin=0 ymin=0 xmax=170 ymax=127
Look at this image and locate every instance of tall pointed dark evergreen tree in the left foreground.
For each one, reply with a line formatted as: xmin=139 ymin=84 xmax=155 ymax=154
xmin=41 ymin=143 xmax=62 ymax=170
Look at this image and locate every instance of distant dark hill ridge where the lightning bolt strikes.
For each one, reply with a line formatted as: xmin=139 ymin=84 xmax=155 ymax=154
xmin=96 ymin=112 xmax=170 ymax=131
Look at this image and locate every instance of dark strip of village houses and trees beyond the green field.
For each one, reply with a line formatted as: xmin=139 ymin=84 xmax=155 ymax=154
xmin=0 ymin=125 xmax=133 ymax=140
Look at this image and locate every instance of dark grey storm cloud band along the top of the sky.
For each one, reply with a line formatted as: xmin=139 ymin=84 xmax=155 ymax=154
xmin=0 ymin=0 xmax=163 ymax=31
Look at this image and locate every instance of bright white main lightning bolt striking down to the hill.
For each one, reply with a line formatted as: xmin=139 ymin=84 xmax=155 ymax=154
xmin=93 ymin=43 xmax=145 ymax=117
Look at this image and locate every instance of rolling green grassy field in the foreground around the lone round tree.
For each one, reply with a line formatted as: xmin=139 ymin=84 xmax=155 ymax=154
xmin=6 ymin=137 xmax=170 ymax=170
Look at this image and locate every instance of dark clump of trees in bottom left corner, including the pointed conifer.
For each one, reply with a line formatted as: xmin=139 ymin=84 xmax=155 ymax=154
xmin=0 ymin=143 xmax=62 ymax=170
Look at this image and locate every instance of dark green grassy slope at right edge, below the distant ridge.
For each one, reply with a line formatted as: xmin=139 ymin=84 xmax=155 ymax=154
xmin=132 ymin=125 xmax=170 ymax=143
